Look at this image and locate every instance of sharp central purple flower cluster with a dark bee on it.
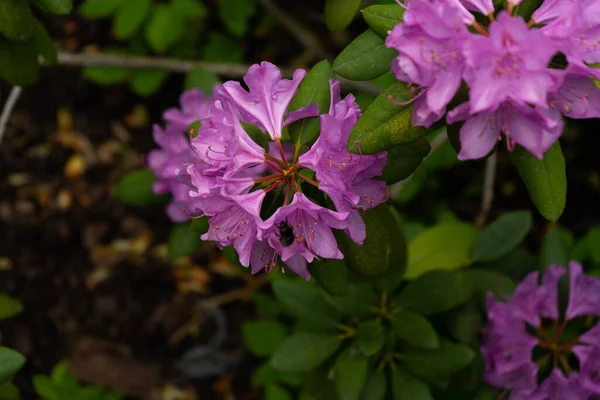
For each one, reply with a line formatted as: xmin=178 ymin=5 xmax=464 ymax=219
xmin=162 ymin=62 xmax=387 ymax=279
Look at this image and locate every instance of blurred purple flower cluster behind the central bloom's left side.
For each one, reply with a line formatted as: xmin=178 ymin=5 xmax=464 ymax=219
xmin=147 ymin=89 xmax=212 ymax=222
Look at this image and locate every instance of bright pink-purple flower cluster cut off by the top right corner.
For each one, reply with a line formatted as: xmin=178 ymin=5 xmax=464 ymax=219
xmin=386 ymin=0 xmax=600 ymax=160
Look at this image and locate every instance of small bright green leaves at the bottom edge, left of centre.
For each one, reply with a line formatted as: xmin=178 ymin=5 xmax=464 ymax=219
xmin=33 ymin=362 xmax=123 ymax=400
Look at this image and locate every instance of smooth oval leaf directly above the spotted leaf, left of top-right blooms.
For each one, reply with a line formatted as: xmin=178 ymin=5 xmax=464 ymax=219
xmin=333 ymin=29 xmax=398 ymax=81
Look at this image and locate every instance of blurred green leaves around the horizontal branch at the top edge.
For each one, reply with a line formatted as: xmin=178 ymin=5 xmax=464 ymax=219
xmin=79 ymin=0 xmax=257 ymax=96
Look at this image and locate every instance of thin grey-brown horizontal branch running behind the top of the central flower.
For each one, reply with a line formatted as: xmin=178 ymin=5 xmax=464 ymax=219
xmin=49 ymin=52 xmax=382 ymax=95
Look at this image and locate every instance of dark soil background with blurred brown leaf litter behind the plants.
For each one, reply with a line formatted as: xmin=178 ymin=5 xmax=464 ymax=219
xmin=0 ymin=0 xmax=600 ymax=400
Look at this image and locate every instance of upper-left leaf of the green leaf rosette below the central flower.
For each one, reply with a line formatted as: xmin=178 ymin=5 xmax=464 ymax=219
xmin=273 ymin=281 xmax=340 ymax=330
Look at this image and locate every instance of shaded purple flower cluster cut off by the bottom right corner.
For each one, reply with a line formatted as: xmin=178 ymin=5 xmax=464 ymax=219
xmin=481 ymin=261 xmax=600 ymax=400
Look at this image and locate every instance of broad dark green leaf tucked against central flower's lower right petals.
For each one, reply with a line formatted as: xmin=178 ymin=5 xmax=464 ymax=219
xmin=342 ymin=204 xmax=406 ymax=277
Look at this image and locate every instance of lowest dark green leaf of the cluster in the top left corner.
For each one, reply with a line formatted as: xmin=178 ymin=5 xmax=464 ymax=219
xmin=0 ymin=35 xmax=39 ymax=86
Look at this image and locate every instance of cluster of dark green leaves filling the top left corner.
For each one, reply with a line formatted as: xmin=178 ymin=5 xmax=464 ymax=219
xmin=0 ymin=0 xmax=73 ymax=86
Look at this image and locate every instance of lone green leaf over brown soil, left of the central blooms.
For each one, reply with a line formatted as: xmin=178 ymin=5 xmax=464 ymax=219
xmin=116 ymin=168 xmax=169 ymax=206
